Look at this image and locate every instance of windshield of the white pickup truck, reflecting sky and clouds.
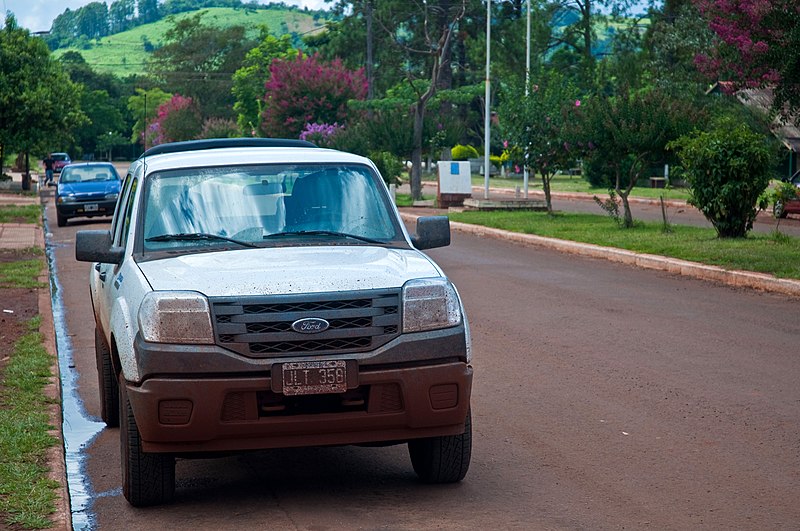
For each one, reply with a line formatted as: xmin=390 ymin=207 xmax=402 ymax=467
xmin=142 ymin=164 xmax=402 ymax=251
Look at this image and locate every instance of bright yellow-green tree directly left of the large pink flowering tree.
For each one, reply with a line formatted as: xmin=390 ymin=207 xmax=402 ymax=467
xmin=232 ymin=26 xmax=299 ymax=134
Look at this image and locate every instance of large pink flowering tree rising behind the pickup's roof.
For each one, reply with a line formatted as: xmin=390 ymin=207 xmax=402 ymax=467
xmin=261 ymin=55 xmax=367 ymax=138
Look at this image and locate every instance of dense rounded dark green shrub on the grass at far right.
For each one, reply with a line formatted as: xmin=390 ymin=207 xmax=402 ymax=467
xmin=670 ymin=122 xmax=773 ymax=238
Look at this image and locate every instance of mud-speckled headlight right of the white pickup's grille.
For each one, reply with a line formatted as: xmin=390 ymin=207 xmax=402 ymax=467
xmin=403 ymin=278 xmax=461 ymax=332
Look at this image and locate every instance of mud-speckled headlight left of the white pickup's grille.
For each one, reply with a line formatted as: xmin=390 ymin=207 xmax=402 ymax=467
xmin=139 ymin=291 xmax=214 ymax=344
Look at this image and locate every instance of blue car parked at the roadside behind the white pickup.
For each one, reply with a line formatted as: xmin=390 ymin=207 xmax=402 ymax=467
xmin=56 ymin=162 xmax=120 ymax=227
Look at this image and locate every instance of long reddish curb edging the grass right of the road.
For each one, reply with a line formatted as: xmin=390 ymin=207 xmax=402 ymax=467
xmin=400 ymin=212 xmax=800 ymax=297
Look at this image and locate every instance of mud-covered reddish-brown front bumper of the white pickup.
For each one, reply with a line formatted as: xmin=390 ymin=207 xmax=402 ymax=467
xmin=126 ymin=361 xmax=472 ymax=454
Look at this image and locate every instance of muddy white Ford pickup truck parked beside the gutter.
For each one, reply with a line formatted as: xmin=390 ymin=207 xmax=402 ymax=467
xmin=75 ymin=139 xmax=472 ymax=506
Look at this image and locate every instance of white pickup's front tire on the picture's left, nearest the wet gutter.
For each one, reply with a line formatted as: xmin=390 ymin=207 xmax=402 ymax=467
xmin=118 ymin=374 xmax=175 ymax=507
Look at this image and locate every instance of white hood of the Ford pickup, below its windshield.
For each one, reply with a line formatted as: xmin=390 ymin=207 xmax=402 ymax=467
xmin=139 ymin=246 xmax=442 ymax=297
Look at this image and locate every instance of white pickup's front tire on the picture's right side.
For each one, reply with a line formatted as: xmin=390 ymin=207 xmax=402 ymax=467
xmin=408 ymin=412 xmax=472 ymax=483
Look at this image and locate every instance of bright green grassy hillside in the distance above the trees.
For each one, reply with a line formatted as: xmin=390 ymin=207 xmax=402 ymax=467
xmin=53 ymin=7 xmax=325 ymax=77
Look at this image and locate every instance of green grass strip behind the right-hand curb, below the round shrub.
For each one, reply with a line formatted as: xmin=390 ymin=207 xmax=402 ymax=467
xmin=449 ymin=211 xmax=800 ymax=279
